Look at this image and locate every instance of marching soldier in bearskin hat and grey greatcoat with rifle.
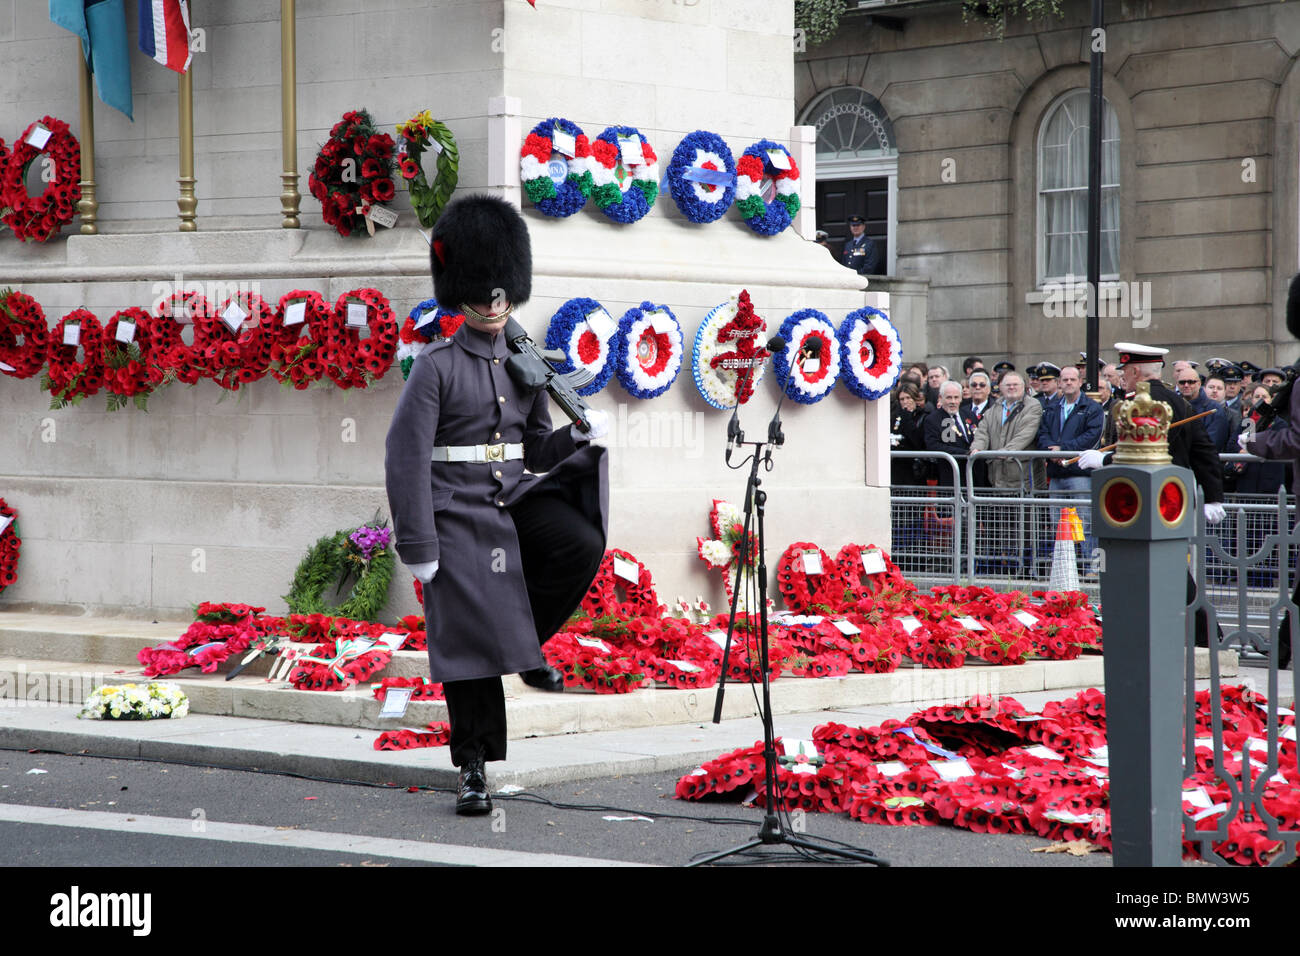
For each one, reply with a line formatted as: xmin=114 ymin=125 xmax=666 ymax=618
xmin=384 ymin=196 xmax=608 ymax=814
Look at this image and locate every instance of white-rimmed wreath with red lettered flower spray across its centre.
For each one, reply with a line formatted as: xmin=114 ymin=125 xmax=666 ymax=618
xmin=690 ymin=290 xmax=768 ymax=410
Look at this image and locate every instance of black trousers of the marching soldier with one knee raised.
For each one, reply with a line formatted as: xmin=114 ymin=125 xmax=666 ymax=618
xmin=442 ymin=494 xmax=605 ymax=767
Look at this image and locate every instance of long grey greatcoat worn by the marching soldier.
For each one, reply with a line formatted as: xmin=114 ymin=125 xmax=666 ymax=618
xmin=385 ymin=325 xmax=608 ymax=682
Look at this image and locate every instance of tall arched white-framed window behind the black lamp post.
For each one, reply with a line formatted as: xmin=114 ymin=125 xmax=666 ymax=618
xmin=1037 ymin=90 xmax=1119 ymax=286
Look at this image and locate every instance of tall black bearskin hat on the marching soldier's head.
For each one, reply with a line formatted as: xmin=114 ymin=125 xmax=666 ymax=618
xmin=429 ymin=195 xmax=533 ymax=308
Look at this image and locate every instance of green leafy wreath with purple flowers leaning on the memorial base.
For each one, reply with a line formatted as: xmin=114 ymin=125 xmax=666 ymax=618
xmin=283 ymin=516 xmax=394 ymax=620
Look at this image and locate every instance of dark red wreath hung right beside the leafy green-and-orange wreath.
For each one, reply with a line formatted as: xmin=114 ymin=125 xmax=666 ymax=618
xmin=307 ymin=109 xmax=397 ymax=235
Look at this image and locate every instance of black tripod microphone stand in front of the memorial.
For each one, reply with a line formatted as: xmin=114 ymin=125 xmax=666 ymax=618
xmin=686 ymin=346 xmax=889 ymax=866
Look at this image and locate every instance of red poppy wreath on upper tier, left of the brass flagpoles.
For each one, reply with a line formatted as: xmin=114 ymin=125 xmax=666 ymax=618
xmin=0 ymin=116 xmax=81 ymax=242
